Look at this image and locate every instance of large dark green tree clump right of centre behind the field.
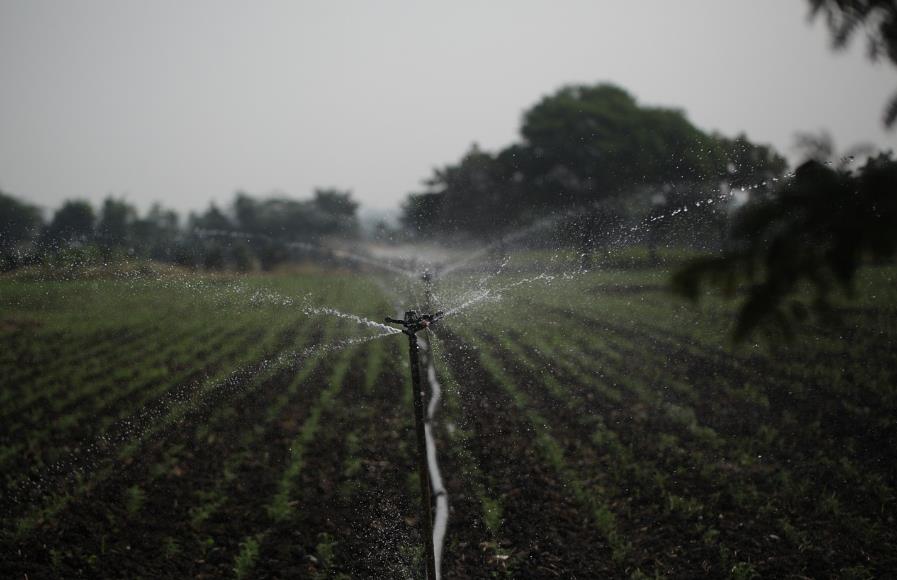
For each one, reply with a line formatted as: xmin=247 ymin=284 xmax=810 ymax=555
xmin=401 ymin=84 xmax=787 ymax=238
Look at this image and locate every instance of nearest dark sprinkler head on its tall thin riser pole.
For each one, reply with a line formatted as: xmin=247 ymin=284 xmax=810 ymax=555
xmin=386 ymin=310 xmax=443 ymax=580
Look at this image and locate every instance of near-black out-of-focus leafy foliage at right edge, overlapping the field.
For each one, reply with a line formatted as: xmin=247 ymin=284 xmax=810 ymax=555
xmin=673 ymin=153 xmax=897 ymax=341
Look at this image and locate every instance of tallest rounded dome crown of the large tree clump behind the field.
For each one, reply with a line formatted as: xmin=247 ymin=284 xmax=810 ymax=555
xmin=520 ymin=84 xmax=726 ymax=203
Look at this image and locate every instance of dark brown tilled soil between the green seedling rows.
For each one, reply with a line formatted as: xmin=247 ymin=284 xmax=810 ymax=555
xmin=0 ymin=311 xmax=897 ymax=579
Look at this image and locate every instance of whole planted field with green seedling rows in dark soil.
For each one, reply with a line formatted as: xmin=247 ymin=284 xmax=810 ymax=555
xmin=0 ymin=263 xmax=897 ymax=579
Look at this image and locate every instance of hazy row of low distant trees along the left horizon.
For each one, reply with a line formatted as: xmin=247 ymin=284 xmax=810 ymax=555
xmin=0 ymin=189 xmax=359 ymax=271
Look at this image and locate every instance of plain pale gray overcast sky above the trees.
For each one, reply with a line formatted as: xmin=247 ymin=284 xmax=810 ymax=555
xmin=0 ymin=0 xmax=897 ymax=218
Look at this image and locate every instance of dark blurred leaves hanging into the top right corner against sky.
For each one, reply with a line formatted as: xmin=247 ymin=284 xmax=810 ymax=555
xmin=809 ymin=0 xmax=897 ymax=127
